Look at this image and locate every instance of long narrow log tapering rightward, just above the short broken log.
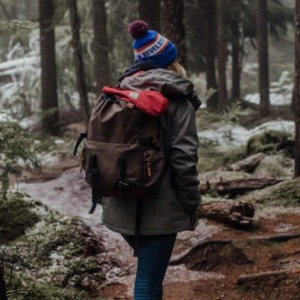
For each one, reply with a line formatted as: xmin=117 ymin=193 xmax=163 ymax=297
xmin=200 ymin=177 xmax=284 ymax=197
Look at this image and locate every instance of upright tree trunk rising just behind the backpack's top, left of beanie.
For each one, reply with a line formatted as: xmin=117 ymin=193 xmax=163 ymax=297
xmin=93 ymin=0 xmax=110 ymax=92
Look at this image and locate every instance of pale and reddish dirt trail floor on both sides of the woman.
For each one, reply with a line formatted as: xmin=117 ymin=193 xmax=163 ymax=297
xmin=18 ymin=148 xmax=300 ymax=300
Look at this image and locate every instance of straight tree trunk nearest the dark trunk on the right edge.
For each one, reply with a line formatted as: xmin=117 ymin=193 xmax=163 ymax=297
xmin=256 ymin=0 xmax=270 ymax=116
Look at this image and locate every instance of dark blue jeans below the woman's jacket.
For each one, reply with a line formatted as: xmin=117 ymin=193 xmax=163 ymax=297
xmin=123 ymin=233 xmax=176 ymax=300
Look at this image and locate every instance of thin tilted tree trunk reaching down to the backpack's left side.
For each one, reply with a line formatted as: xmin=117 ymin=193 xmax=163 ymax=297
xmin=69 ymin=0 xmax=90 ymax=125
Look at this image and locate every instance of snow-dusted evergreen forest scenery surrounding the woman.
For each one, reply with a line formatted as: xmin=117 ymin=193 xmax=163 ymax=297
xmin=0 ymin=0 xmax=300 ymax=300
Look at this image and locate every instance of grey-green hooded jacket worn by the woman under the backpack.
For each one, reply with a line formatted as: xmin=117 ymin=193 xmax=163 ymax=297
xmin=102 ymin=69 xmax=201 ymax=235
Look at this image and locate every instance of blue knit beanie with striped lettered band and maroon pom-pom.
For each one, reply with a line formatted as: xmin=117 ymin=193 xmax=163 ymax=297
xmin=128 ymin=20 xmax=177 ymax=68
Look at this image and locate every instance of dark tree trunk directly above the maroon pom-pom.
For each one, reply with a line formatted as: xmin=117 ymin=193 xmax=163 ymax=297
xmin=139 ymin=0 xmax=161 ymax=32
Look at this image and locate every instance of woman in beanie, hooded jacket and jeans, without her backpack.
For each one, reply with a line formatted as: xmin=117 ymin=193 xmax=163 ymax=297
xmin=102 ymin=20 xmax=201 ymax=300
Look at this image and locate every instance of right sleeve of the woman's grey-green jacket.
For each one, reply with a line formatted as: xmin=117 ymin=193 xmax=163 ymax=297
xmin=169 ymin=99 xmax=201 ymax=214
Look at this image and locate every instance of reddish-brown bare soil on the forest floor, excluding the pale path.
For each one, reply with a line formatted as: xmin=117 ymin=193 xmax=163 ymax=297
xmin=101 ymin=214 xmax=300 ymax=300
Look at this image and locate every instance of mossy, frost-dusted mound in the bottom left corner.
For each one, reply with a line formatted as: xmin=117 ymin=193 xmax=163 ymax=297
xmin=1 ymin=193 xmax=105 ymax=300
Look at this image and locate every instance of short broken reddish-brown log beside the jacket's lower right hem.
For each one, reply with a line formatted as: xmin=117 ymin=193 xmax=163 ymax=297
xmin=198 ymin=200 xmax=255 ymax=227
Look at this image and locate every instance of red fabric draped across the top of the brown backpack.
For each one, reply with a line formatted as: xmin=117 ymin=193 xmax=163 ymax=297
xmin=102 ymin=86 xmax=168 ymax=116
